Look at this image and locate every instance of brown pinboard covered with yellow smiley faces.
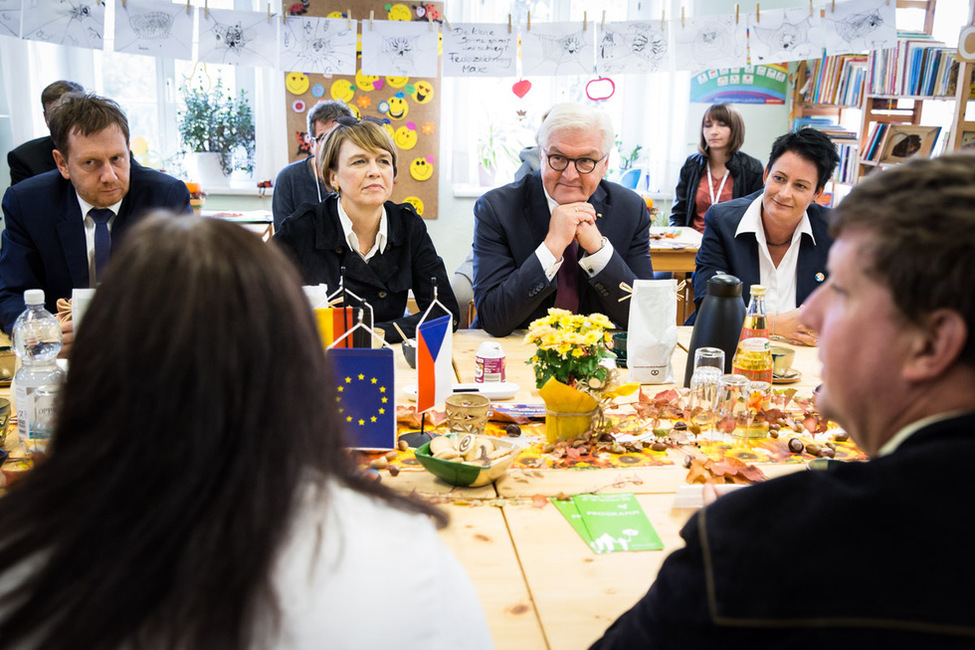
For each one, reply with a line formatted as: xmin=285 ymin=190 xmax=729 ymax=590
xmin=283 ymin=0 xmax=443 ymax=219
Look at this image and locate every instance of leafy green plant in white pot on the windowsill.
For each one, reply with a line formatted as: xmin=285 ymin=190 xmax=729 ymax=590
xmin=176 ymin=80 xmax=254 ymax=182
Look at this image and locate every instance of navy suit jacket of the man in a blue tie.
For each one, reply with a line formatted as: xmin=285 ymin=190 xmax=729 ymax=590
xmin=0 ymin=160 xmax=190 ymax=333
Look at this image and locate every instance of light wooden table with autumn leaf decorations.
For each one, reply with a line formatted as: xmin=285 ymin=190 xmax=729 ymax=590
xmin=384 ymin=327 xmax=819 ymax=649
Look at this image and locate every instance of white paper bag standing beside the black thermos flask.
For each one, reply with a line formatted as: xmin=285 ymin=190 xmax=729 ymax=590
xmin=626 ymin=280 xmax=677 ymax=384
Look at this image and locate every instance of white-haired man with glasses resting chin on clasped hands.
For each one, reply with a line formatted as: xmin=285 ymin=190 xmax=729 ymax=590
xmin=473 ymin=103 xmax=653 ymax=336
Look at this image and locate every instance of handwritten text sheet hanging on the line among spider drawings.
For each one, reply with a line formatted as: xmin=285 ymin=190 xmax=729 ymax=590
xmin=443 ymin=23 xmax=518 ymax=77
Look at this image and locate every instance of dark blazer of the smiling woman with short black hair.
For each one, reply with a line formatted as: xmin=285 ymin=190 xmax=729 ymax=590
xmin=688 ymin=190 xmax=833 ymax=310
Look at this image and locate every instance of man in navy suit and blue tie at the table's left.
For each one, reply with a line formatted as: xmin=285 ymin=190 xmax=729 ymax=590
xmin=0 ymin=95 xmax=190 ymax=333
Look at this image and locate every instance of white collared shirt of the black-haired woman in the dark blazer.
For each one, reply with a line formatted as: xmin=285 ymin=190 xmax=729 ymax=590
xmin=735 ymin=196 xmax=816 ymax=314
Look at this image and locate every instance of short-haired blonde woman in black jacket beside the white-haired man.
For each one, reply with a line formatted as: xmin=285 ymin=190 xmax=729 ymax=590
xmin=274 ymin=117 xmax=460 ymax=342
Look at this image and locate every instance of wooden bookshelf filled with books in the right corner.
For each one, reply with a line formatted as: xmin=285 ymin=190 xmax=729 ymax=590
xmin=790 ymin=0 xmax=975 ymax=198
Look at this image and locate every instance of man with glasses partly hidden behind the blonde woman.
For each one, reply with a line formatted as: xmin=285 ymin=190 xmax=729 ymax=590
xmin=271 ymin=100 xmax=352 ymax=231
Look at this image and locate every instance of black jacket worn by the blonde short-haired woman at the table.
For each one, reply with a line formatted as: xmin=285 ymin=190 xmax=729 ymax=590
xmin=274 ymin=194 xmax=460 ymax=342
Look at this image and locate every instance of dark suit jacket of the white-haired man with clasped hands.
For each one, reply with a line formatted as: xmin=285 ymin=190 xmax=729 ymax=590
xmin=474 ymin=172 xmax=653 ymax=336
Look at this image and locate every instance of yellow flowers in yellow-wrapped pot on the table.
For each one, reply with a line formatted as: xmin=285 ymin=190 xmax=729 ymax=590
xmin=525 ymin=309 xmax=639 ymax=442
